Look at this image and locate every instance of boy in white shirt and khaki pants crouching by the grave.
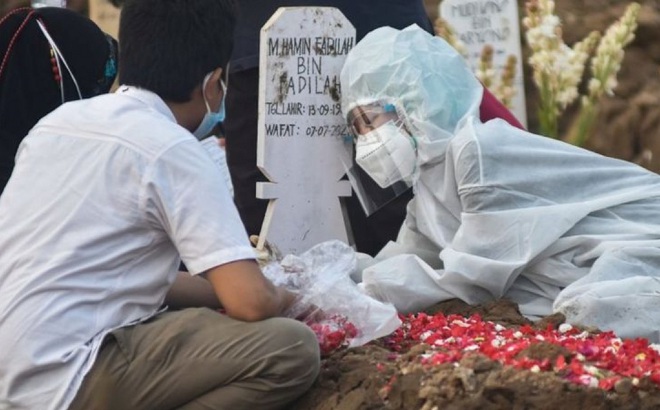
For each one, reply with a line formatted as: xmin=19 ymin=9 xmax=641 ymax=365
xmin=0 ymin=0 xmax=320 ymax=410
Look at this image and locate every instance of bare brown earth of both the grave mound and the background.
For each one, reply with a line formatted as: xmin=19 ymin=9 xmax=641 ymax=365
xmin=291 ymin=0 xmax=660 ymax=410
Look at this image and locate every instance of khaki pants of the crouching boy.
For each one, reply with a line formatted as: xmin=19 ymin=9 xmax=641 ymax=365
xmin=70 ymin=308 xmax=319 ymax=410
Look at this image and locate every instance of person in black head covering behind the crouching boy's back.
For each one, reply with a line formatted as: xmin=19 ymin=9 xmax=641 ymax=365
xmin=0 ymin=7 xmax=117 ymax=194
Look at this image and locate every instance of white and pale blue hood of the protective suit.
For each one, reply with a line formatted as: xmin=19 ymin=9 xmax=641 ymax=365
xmin=341 ymin=25 xmax=483 ymax=165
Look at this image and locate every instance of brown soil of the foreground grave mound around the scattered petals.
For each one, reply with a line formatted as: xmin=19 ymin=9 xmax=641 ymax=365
xmin=289 ymin=300 xmax=660 ymax=410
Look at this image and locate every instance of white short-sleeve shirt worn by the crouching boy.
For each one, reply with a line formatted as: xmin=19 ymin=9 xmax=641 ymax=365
xmin=0 ymin=87 xmax=254 ymax=410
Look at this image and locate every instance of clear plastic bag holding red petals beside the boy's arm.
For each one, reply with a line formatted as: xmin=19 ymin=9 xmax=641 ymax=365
xmin=262 ymin=241 xmax=401 ymax=353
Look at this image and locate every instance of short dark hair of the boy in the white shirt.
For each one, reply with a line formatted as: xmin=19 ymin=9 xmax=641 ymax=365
xmin=119 ymin=0 xmax=236 ymax=103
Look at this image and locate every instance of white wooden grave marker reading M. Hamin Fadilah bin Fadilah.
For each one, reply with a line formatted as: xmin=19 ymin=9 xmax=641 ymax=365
xmin=257 ymin=7 xmax=355 ymax=254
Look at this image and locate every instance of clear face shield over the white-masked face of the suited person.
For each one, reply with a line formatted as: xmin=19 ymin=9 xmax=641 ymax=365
xmin=344 ymin=103 xmax=417 ymax=215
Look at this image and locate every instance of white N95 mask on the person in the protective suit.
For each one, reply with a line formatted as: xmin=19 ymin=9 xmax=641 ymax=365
xmin=355 ymin=121 xmax=417 ymax=188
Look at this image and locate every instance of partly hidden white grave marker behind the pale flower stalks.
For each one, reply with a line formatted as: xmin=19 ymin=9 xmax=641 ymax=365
xmin=439 ymin=0 xmax=527 ymax=126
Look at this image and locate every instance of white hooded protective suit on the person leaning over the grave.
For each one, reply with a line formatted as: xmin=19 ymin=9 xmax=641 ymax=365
xmin=341 ymin=26 xmax=660 ymax=342
